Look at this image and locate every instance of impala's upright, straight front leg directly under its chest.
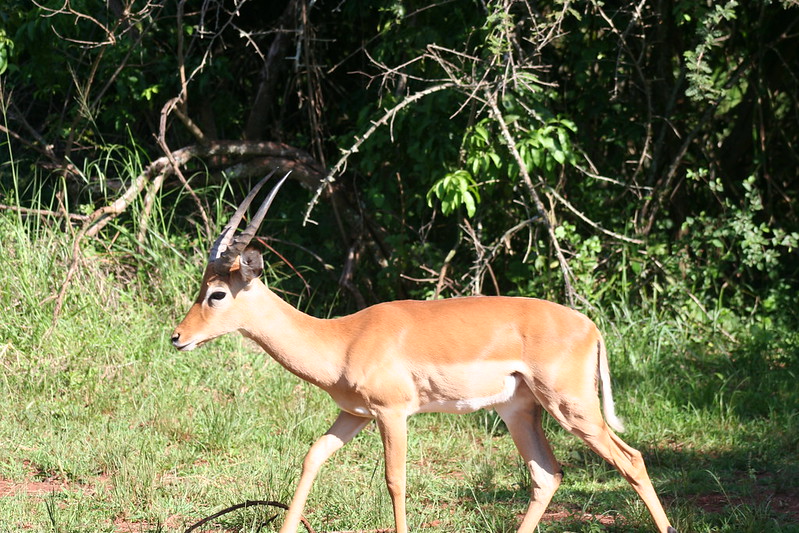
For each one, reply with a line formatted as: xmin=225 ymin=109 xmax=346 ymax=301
xmin=377 ymin=413 xmax=408 ymax=533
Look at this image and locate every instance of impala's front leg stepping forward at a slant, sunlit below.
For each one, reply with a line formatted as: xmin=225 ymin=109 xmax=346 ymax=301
xmin=280 ymin=411 xmax=371 ymax=533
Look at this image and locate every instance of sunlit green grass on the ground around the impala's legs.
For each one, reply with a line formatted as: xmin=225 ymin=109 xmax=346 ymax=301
xmin=0 ymin=183 xmax=799 ymax=533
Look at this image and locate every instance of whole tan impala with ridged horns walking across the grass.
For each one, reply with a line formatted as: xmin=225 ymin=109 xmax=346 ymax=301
xmin=172 ymin=174 xmax=676 ymax=533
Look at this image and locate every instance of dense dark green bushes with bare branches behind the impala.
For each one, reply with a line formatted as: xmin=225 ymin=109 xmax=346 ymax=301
xmin=0 ymin=0 xmax=799 ymax=329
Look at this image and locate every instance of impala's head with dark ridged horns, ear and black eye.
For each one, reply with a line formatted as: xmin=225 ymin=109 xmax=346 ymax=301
xmin=172 ymin=171 xmax=288 ymax=350
